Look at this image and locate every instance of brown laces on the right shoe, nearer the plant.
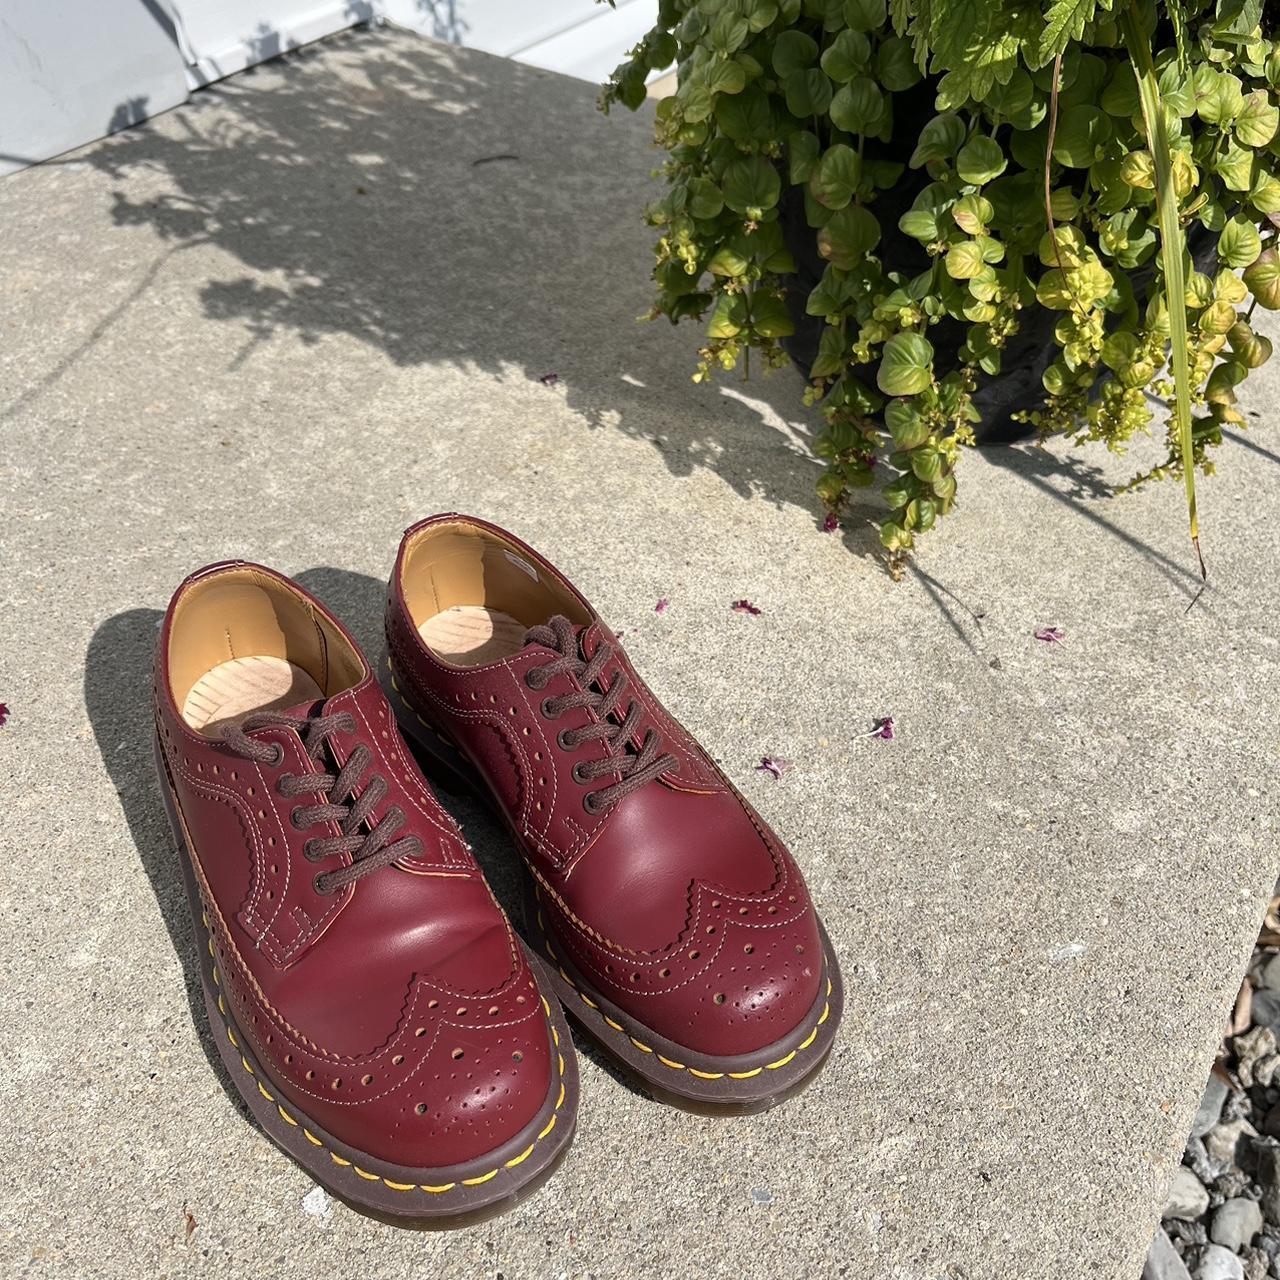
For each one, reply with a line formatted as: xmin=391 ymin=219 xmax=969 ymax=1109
xmin=525 ymin=614 xmax=676 ymax=814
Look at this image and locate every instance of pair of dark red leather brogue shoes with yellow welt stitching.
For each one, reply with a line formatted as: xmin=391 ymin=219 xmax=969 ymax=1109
xmin=155 ymin=515 xmax=841 ymax=1221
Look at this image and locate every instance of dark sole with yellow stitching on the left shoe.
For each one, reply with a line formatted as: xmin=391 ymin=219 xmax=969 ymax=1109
xmin=156 ymin=742 xmax=579 ymax=1229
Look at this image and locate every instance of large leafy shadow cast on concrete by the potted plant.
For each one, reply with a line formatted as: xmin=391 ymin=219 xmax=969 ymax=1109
xmin=77 ymin=31 xmax=1198 ymax=577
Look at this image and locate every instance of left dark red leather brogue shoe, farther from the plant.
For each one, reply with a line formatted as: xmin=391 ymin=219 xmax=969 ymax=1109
xmin=155 ymin=562 xmax=577 ymax=1222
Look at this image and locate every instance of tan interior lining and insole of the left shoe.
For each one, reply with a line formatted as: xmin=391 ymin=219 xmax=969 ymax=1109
xmin=169 ymin=568 xmax=365 ymax=733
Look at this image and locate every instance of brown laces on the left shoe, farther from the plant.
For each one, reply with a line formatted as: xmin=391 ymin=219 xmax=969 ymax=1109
xmin=223 ymin=712 xmax=422 ymax=893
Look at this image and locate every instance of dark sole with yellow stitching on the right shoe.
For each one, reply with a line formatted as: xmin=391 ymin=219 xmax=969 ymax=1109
xmin=384 ymin=659 xmax=845 ymax=1115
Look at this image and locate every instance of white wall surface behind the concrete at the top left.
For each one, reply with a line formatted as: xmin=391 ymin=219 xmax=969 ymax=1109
xmin=0 ymin=0 xmax=658 ymax=174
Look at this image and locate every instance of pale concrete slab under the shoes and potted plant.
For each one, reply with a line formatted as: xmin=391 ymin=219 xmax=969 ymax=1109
xmin=0 ymin=22 xmax=1280 ymax=1280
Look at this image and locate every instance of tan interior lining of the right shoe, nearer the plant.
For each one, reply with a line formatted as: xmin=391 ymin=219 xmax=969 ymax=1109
xmin=401 ymin=524 xmax=590 ymax=667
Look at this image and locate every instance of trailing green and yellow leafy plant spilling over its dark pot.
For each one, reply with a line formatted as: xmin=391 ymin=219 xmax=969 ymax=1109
xmin=602 ymin=0 xmax=1280 ymax=564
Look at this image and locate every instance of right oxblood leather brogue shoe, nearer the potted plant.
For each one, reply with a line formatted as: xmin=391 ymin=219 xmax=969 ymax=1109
xmin=387 ymin=515 xmax=842 ymax=1111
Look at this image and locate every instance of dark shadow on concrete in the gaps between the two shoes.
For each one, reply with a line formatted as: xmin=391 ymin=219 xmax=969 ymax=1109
xmin=298 ymin=568 xmax=649 ymax=1101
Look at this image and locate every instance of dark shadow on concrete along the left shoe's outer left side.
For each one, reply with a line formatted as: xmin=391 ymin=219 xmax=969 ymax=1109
xmin=84 ymin=609 xmax=256 ymax=1128
